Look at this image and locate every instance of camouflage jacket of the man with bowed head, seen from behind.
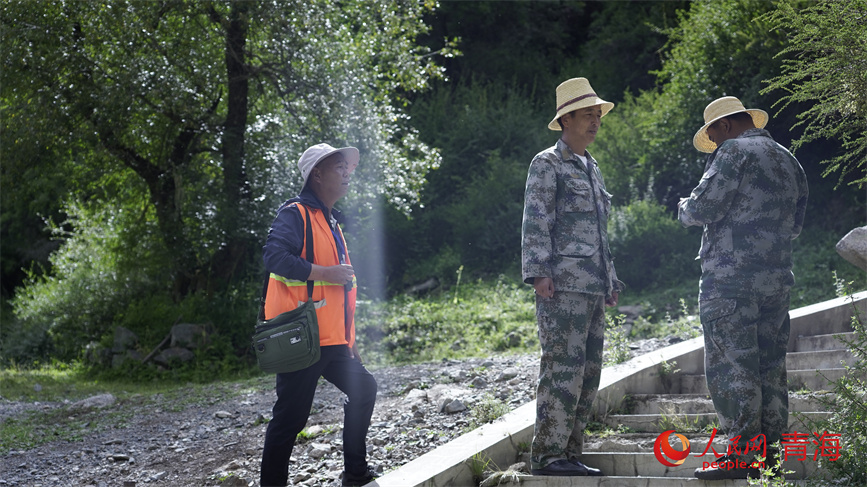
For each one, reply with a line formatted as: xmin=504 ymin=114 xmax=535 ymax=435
xmin=678 ymin=129 xmax=808 ymax=300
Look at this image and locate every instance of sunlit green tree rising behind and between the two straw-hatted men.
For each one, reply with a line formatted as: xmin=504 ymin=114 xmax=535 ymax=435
xmin=624 ymin=0 xmax=788 ymax=207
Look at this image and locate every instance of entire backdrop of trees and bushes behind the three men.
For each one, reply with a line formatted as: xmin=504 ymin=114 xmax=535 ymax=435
xmin=0 ymin=0 xmax=867 ymax=369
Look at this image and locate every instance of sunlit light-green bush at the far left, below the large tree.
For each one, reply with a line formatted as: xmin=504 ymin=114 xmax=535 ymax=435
xmin=2 ymin=200 xmax=168 ymax=363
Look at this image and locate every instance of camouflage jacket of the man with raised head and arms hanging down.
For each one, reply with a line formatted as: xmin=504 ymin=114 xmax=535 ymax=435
xmin=521 ymin=140 xmax=623 ymax=296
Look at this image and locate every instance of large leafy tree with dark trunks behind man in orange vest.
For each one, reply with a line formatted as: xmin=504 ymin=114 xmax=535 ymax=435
xmin=0 ymin=0 xmax=442 ymax=364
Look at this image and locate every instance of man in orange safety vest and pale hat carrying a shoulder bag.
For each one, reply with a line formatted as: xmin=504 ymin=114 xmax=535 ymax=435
xmin=260 ymin=144 xmax=377 ymax=486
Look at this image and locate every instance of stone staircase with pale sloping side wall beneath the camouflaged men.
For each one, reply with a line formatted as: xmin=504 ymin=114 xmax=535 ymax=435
xmin=370 ymin=292 xmax=867 ymax=487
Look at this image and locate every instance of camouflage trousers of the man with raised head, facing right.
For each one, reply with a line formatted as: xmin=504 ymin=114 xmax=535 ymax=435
xmin=531 ymin=292 xmax=605 ymax=469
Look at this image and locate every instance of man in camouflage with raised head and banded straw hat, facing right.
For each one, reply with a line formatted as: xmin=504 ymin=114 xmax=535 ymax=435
xmin=521 ymin=78 xmax=623 ymax=476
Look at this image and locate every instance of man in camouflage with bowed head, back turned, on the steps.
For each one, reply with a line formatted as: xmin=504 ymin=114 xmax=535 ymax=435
xmin=678 ymin=96 xmax=807 ymax=480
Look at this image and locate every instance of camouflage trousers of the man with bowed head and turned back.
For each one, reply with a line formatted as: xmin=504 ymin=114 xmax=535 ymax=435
xmin=700 ymin=293 xmax=789 ymax=452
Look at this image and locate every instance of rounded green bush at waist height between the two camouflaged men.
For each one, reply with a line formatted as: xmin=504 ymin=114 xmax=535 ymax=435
xmin=608 ymin=200 xmax=701 ymax=292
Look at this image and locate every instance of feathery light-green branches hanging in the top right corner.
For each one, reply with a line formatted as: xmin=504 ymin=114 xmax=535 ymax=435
xmin=762 ymin=0 xmax=867 ymax=187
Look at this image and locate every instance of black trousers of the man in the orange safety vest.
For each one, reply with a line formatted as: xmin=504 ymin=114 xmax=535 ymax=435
xmin=260 ymin=345 xmax=376 ymax=487
